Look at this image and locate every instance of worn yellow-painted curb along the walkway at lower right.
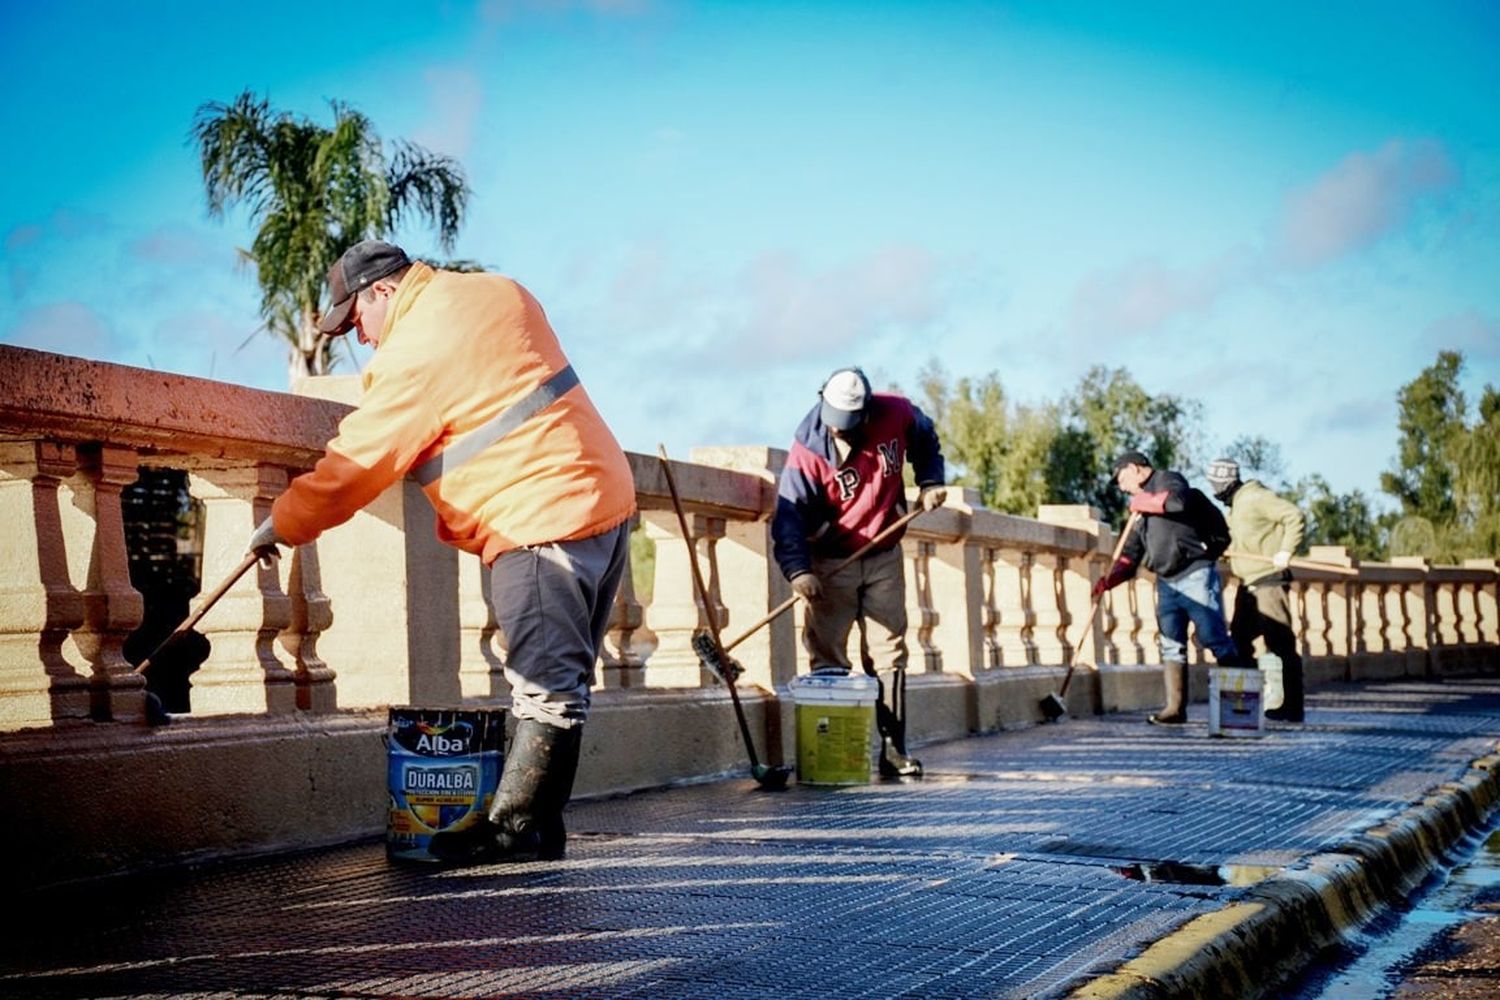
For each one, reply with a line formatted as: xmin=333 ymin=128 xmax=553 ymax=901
xmin=1068 ymin=751 xmax=1500 ymax=1000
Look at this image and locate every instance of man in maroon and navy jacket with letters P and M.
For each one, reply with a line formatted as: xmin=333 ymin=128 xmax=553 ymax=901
xmin=771 ymin=367 xmax=947 ymax=777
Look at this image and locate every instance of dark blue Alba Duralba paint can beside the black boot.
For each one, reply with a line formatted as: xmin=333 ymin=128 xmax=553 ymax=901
xmin=386 ymin=708 xmax=506 ymax=861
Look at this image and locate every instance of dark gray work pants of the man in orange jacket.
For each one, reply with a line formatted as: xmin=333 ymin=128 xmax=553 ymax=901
xmin=489 ymin=522 xmax=630 ymax=729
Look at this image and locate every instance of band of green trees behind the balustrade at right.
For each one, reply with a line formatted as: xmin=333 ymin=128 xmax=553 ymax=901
xmin=920 ymin=351 xmax=1500 ymax=562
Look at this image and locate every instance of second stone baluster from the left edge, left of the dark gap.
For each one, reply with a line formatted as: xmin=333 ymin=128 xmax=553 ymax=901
xmin=63 ymin=445 xmax=146 ymax=723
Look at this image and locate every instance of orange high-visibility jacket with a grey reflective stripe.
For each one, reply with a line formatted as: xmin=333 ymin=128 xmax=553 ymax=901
xmin=272 ymin=264 xmax=636 ymax=564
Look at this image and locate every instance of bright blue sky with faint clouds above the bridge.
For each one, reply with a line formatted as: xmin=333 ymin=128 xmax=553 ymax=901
xmin=0 ymin=0 xmax=1500 ymax=495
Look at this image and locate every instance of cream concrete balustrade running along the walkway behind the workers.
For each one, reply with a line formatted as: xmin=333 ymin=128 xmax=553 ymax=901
xmin=0 ymin=346 xmax=1500 ymax=880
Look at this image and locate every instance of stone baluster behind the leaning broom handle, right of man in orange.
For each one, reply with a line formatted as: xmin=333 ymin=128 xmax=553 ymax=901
xmin=642 ymin=510 xmax=728 ymax=688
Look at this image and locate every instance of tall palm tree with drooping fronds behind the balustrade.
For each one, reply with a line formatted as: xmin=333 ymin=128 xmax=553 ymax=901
xmin=191 ymin=90 xmax=470 ymax=378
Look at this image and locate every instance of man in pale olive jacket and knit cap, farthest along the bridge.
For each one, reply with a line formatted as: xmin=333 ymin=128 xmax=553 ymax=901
xmin=1208 ymin=459 xmax=1305 ymax=723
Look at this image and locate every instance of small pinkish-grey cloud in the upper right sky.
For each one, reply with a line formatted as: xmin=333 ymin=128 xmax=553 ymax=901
xmin=1277 ymin=139 xmax=1457 ymax=267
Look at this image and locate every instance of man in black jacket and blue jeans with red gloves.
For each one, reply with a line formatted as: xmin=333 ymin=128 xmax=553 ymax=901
xmin=1094 ymin=451 xmax=1239 ymax=726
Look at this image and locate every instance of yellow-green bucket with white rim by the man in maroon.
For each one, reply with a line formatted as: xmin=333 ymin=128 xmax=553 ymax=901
xmin=788 ymin=667 xmax=881 ymax=784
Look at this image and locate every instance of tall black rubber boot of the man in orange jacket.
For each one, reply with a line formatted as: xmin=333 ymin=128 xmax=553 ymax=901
xmin=489 ymin=720 xmax=584 ymax=861
